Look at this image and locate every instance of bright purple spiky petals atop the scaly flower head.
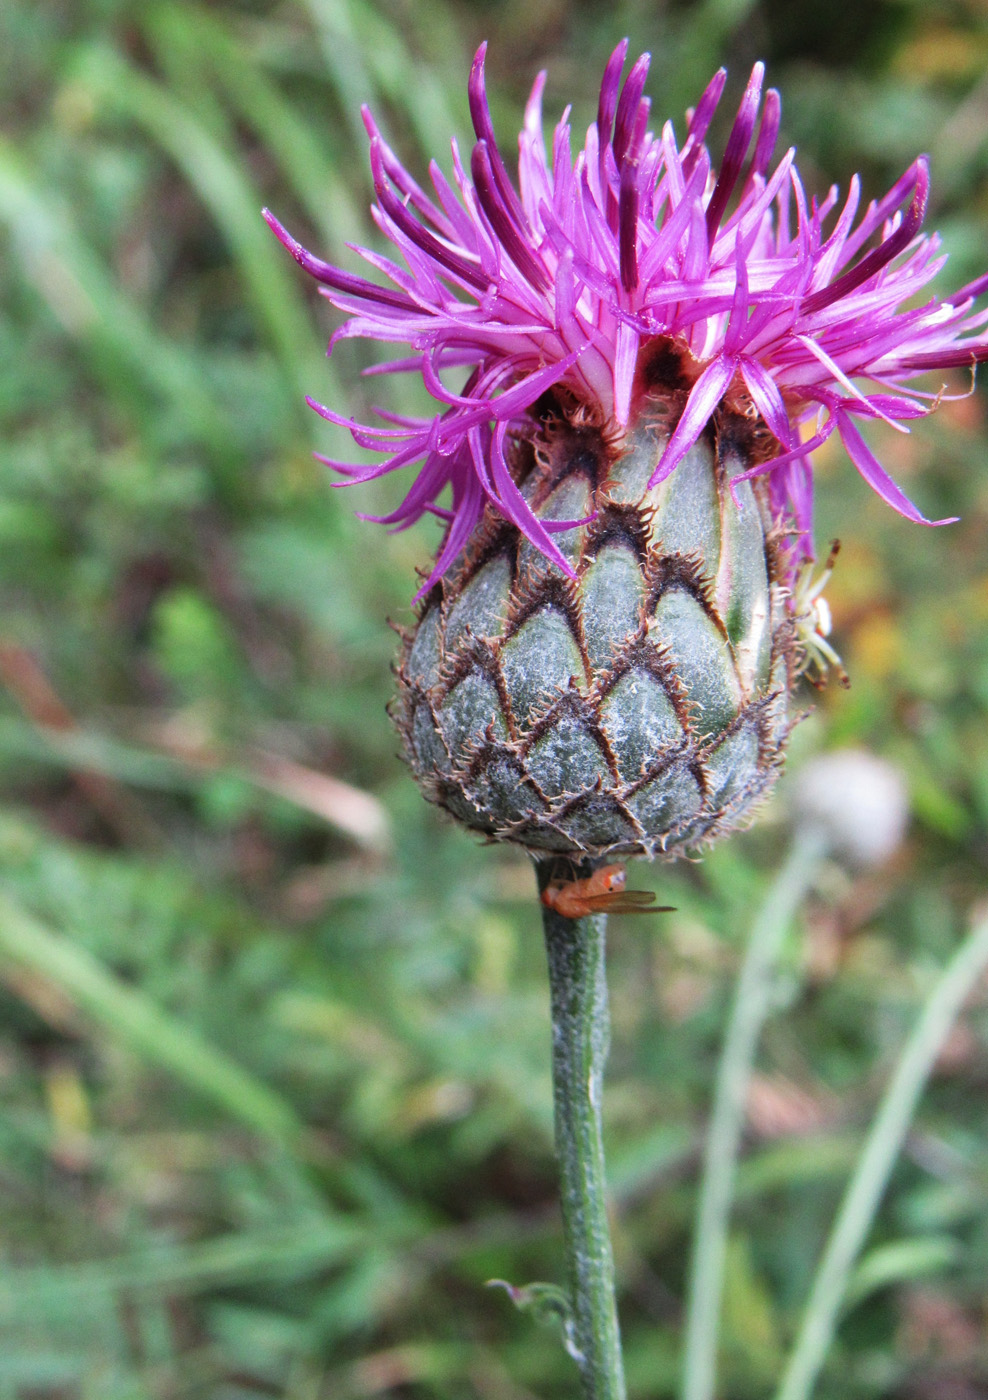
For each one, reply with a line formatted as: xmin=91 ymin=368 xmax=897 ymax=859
xmin=264 ymin=41 xmax=988 ymax=588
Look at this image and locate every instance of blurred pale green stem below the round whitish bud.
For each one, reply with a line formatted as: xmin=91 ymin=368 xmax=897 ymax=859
xmin=680 ymin=829 xmax=826 ymax=1400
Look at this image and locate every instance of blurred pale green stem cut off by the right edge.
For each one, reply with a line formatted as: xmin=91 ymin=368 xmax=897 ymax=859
xmin=775 ymin=916 xmax=988 ymax=1400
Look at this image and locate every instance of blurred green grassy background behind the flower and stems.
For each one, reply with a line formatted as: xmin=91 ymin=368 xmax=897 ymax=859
xmin=0 ymin=0 xmax=988 ymax=1400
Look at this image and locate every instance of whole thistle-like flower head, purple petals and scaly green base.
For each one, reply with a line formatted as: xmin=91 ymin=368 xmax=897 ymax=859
xmin=266 ymin=43 xmax=988 ymax=857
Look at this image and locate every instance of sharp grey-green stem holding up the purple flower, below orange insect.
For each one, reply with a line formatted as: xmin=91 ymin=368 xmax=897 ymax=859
xmin=537 ymin=860 xmax=626 ymax=1400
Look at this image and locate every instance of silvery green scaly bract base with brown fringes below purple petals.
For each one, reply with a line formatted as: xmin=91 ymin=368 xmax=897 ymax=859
xmin=396 ymin=384 xmax=793 ymax=857
